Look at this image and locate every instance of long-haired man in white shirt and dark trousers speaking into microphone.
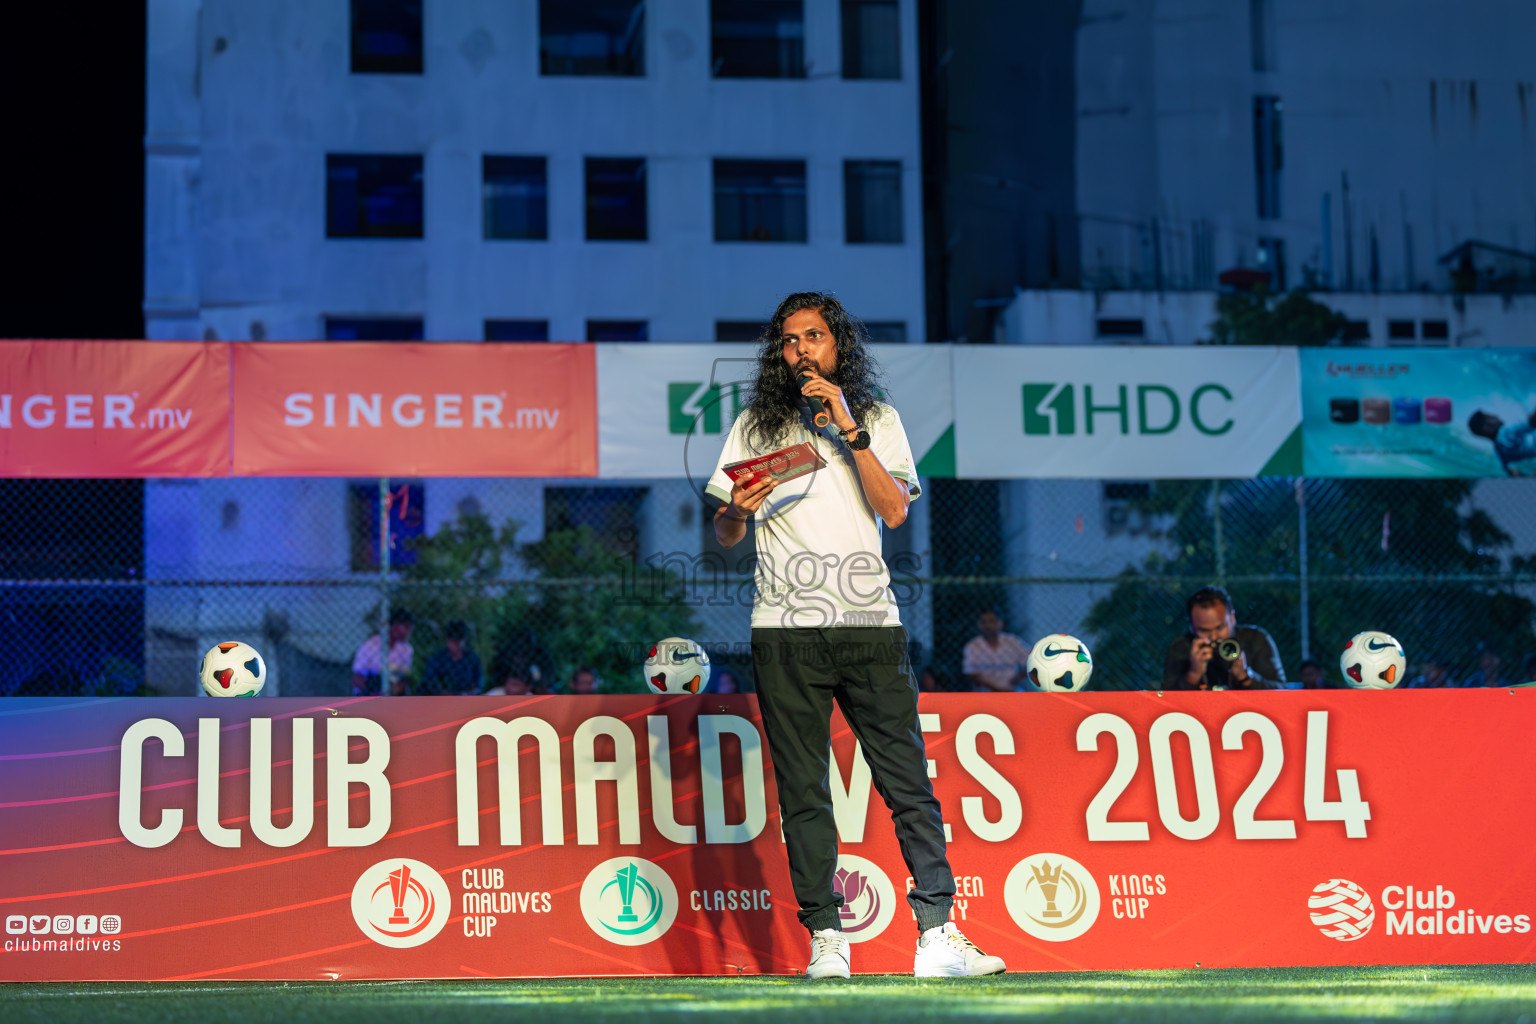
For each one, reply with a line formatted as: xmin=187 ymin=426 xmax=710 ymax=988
xmin=707 ymin=292 xmax=1005 ymax=978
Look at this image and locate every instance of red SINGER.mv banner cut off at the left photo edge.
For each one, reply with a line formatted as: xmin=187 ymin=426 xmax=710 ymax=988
xmin=0 ymin=341 xmax=229 ymax=477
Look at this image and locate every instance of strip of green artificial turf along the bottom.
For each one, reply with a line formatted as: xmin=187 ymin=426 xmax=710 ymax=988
xmin=0 ymin=964 xmax=1536 ymax=1024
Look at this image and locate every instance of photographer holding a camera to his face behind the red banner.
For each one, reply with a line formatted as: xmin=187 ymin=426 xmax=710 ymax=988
xmin=1163 ymin=586 xmax=1286 ymax=689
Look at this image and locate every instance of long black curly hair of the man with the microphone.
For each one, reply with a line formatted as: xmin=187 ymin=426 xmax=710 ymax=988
xmin=742 ymin=292 xmax=883 ymax=451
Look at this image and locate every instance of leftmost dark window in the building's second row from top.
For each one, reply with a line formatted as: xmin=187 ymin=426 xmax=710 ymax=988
xmin=326 ymin=154 xmax=422 ymax=238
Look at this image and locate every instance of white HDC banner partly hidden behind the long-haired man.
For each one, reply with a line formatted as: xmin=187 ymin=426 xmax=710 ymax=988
xmin=598 ymin=344 xmax=955 ymax=484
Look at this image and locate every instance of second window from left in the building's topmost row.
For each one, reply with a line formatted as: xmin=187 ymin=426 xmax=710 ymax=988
xmin=539 ymin=0 xmax=645 ymax=75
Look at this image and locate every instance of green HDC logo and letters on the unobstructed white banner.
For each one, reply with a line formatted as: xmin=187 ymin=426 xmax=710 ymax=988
xmin=1023 ymin=384 xmax=1233 ymax=438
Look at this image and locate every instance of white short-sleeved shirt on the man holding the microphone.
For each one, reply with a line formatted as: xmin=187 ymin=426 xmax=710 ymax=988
xmin=705 ymin=404 xmax=922 ymax=629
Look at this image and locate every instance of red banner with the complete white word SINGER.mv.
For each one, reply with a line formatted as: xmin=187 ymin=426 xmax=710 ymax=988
xmin=233 ymin=342 xmax=598 ymax=476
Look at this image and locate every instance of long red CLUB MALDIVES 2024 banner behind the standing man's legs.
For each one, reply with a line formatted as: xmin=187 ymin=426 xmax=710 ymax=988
xmin=0 ymin=689 xmax=1536 ymax=981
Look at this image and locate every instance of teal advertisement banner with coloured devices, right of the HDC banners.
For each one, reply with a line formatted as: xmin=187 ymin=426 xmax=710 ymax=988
xmin=1301 ymin=348 xmax=1536 ymax=477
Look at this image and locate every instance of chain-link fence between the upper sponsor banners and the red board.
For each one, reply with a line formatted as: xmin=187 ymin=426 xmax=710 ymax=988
xmin=0 ymin=479 xmax=1536 ymax=695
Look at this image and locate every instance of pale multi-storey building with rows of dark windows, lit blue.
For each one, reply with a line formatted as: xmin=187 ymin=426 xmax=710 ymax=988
xmin=144 ymin=0 xmax=925 ymax=693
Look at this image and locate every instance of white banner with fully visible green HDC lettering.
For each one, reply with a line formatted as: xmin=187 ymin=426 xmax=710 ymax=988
xmin=952 ymin=345 xmax=1301 ymax=479
